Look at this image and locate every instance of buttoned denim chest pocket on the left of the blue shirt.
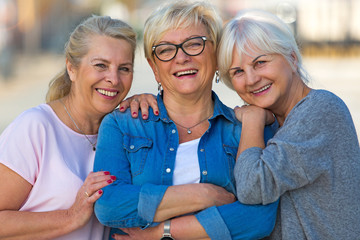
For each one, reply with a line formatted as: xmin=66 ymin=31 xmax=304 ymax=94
xmin=123 ymin=135 xmax=153 ymax=177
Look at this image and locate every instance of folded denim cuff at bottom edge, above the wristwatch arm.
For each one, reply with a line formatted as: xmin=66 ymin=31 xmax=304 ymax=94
xmin=195 ymin=206 xmax=231 ymax=240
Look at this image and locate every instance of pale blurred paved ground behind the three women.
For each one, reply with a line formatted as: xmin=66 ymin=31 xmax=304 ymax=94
xmin=0 ymin=54 xmax=360 ymax=137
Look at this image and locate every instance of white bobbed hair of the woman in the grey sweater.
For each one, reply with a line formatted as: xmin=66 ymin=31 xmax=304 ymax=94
xmin=218 ymin=10 xmax=310 ymax=89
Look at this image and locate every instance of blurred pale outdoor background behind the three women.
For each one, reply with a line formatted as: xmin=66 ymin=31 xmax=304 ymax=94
xmin=0 ymin=0 xmax=360 ymax=139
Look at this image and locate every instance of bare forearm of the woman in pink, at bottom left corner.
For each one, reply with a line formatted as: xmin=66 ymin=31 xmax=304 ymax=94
xmin=0 ymin=210 xmax=80 ymax=240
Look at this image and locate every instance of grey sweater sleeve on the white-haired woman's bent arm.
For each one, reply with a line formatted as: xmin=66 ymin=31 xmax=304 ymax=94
xmin=234 ymin=89 xmax=356 ymax=204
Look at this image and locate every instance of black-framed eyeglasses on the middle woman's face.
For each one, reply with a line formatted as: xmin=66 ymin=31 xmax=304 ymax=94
xmin=152 ymin=36 xmax=207 ymax=62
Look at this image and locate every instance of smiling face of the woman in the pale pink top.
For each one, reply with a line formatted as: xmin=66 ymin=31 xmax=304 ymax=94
xmin=67 ymin=36 xmax=133 ymax=114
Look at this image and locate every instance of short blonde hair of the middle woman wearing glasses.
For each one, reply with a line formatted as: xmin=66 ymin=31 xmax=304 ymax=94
xmin=144 ymin=0 xmax=222 ymax=65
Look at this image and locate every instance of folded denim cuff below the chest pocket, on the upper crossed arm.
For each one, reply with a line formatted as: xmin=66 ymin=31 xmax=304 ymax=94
xmin=138 ymin=183 xmax=168 ymax=227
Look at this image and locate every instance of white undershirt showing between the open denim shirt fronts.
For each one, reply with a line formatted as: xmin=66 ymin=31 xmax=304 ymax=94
xmin=173 ymin=138 xmax=200 ymax=185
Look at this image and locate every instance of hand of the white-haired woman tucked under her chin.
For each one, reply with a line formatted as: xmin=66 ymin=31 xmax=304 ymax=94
xmin=234 ymin=105 xmax=275 ymax=125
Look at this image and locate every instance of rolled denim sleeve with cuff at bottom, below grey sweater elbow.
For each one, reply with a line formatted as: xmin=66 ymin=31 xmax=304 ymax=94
xmin=196 ymin=201 xmax=278 ymax=240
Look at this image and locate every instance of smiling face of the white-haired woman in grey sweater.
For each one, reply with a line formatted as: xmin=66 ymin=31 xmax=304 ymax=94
xmin=229 ymin=49 xmax=305 ymax=116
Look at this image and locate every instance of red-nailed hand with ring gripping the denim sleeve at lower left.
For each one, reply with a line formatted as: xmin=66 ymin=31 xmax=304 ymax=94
xmin=68 ymin=171 xmax=116 ymax=229
